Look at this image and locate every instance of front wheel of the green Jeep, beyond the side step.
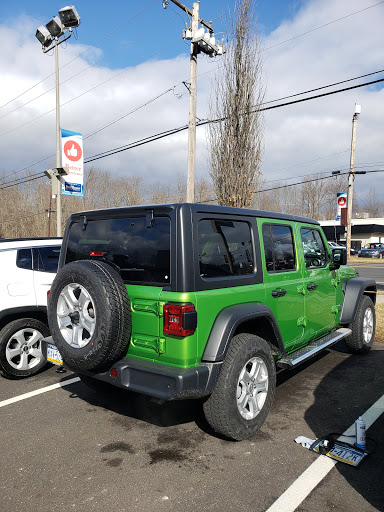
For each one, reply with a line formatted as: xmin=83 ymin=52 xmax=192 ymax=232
xmin=345 ymin=295 xmax=376 ymax=354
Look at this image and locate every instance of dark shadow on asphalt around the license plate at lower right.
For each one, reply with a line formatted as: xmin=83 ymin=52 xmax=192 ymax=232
xmin=305 ymin=344 xmax=384 ymax=511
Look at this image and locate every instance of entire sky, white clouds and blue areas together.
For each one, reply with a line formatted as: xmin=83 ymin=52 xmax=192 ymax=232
xmin=0 ymin=0 xmax=384 ymax=209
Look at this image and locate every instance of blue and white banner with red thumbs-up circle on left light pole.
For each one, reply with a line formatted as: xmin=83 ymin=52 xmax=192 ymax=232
xmin=61 ymin=129 xmax=84 ymax=197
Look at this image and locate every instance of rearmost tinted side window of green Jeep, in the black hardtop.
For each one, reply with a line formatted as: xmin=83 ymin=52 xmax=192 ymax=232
xmin=198 ymin=219 xmax=254 ymax=278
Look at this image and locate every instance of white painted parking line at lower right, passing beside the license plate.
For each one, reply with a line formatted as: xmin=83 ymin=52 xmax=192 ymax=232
xmin=266 ymin=395 xmax=384 ymax=512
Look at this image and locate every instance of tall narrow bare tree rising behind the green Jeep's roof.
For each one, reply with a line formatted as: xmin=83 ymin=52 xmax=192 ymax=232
xmin=208 ymin=0 xmax=265 ymax=207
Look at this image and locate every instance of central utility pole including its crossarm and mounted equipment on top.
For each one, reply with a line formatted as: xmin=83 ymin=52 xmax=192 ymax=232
xmin=163 ymin=0 xmax=225 ymax=203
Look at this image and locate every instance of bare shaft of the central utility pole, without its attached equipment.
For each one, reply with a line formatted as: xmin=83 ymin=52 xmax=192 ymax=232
xmin=187 ymin=2 xmax=199 ymax=203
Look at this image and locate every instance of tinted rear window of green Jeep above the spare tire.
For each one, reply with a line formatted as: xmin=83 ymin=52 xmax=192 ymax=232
xmin=65 ymin=217 xmax=170 ymax=284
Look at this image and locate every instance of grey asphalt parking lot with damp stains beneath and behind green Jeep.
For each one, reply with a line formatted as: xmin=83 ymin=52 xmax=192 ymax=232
xmin=0 ymin=342 xmax=384 ymax=512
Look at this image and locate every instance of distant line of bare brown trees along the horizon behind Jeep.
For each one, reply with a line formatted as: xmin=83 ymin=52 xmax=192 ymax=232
xmin=0 ymin=168 xmax=384 ymax=238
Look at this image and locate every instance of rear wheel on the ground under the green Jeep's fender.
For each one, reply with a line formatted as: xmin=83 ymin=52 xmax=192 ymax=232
xmin=203 ymin=333 xmax=276 ymax=441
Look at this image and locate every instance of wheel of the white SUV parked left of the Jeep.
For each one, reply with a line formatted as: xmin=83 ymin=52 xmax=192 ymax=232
xmin=0 ymin=318 xmax=49 ymax=379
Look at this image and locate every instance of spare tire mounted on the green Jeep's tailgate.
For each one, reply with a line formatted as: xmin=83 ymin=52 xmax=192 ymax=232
xmin=48 ymin=260 xmax=131 ymax=371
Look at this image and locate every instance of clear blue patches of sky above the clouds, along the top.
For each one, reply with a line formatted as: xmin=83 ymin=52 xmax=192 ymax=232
xmin=1 ymin=0 xmax=301 ymax=68
